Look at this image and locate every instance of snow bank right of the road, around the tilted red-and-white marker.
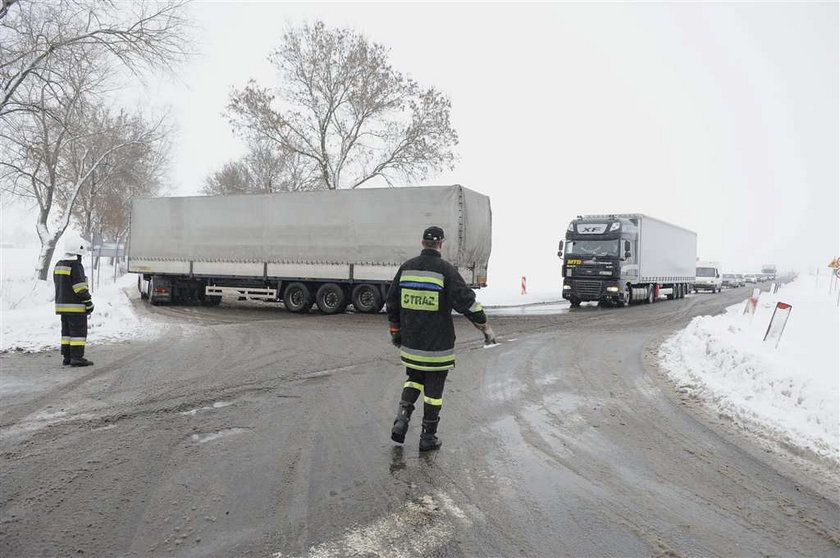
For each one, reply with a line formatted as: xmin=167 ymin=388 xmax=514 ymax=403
xmin=659 ymin=276 xmax=840 ymax=460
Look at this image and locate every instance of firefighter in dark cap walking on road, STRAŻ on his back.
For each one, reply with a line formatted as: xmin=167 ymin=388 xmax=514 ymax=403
xmin=386 ymin=227 xmax=495 ymax=451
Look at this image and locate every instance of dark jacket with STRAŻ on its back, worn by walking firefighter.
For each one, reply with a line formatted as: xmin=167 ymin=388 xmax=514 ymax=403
xmin=386 ymin=249 xmax=487 ymax=370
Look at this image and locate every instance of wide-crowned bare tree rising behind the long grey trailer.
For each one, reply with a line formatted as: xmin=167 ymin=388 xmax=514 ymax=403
xmin=228 ymin=21 xmax=458 ymax=189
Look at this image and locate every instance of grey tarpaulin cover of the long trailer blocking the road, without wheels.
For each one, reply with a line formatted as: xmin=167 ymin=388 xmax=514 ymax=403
xmin=129 ymin=185 xmax=491 ymax=269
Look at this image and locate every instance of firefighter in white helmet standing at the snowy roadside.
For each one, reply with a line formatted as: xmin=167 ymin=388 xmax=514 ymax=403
xmin=53 ymin=235 xmax=93 ymax=366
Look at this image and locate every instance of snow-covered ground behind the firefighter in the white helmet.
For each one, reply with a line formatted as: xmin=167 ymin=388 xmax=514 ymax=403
xmin=0 ymin=247 xmax=162 ymax=351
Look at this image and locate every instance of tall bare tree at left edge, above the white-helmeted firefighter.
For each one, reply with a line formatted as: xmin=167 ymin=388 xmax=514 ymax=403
xmin=0 ymin=0 xmax=186 ymax=279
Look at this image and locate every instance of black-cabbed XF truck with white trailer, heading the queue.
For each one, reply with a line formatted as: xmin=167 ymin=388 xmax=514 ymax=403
xmin=557 ymin=213 xmax=697 ymax=307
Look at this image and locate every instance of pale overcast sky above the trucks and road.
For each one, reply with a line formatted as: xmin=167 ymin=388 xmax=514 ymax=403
xmin=3 ymin=2 xmax=840 ymax=284
